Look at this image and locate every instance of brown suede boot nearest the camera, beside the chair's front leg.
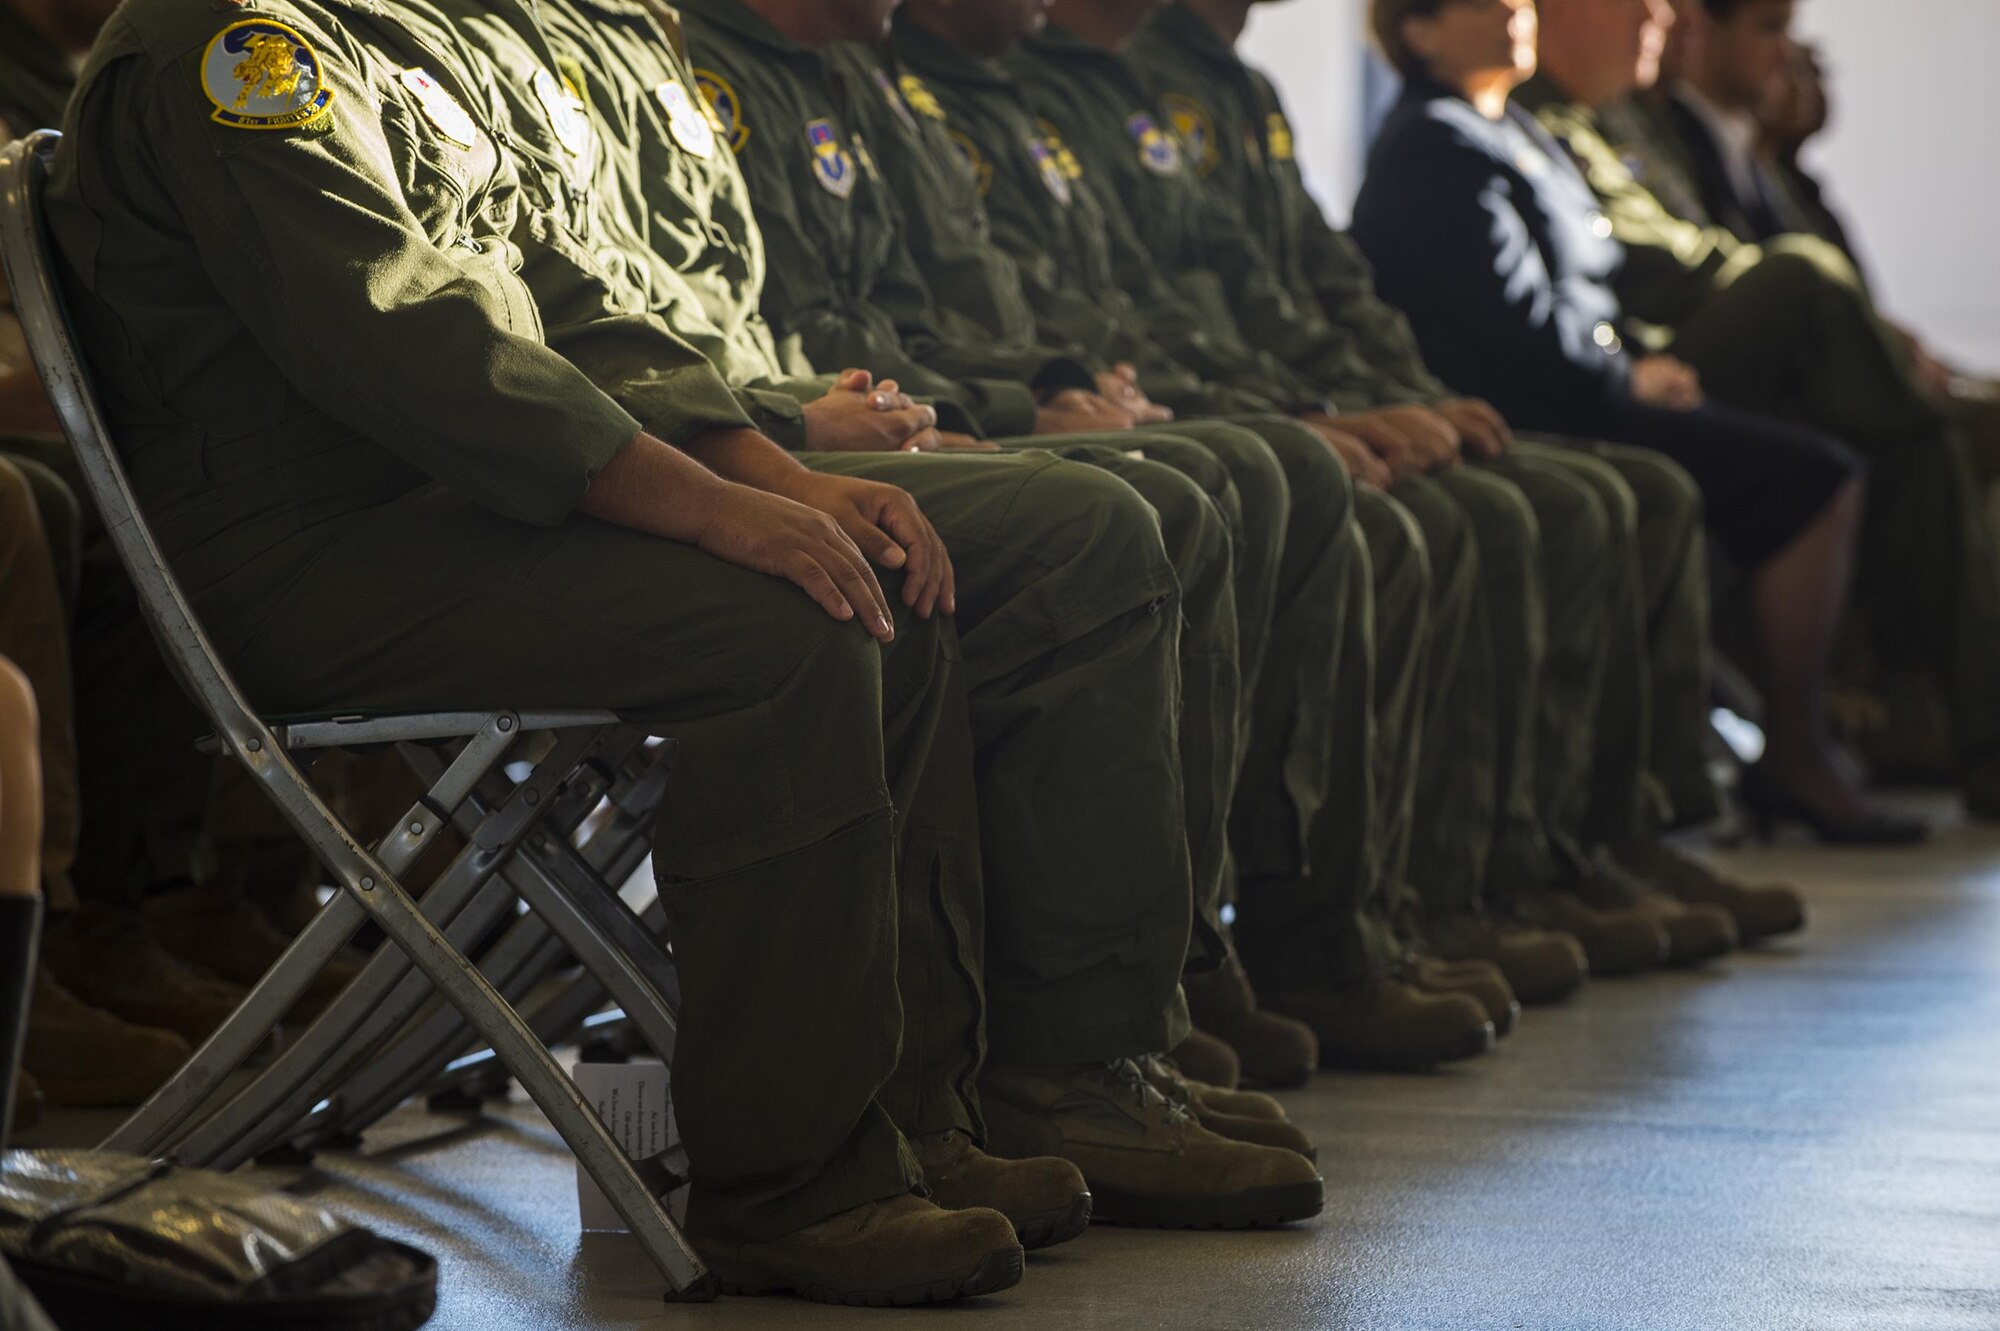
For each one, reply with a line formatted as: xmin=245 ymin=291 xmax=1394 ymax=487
xmin=688 ymin=1193 xmax=1026 ymax=1307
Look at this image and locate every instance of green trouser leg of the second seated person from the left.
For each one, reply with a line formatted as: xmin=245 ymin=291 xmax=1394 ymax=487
xmin=804 ymin=450 xmax=1200 ymax=1063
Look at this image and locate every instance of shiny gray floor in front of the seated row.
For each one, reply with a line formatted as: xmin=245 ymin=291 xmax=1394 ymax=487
xmin=19 ymin=791 xmax=2000 ymax=1331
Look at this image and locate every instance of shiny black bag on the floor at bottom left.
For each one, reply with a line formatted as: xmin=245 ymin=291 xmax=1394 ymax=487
xmin=0 ymin=1151 xmax=438 ymax=1331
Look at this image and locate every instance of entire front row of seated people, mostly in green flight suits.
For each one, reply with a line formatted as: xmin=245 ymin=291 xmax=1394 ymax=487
xmin=0 ymin=0 xmax=2000 ymax=1299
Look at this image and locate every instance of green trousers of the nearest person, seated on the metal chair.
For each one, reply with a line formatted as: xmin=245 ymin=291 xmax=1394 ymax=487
xmin=219 ymin=490 xmax=960 ymax=1235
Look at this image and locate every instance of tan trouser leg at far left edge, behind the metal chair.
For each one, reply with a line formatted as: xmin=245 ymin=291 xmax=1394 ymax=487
xmin=0 ymin=458 xmax=76 ymax=911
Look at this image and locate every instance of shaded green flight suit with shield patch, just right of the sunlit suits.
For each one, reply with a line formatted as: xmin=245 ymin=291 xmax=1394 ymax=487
xmin=686 ymin=0 xmax=1284 ymax=963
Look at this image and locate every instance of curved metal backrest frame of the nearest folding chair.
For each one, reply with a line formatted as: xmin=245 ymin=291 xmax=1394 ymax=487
xmin=0 ymin=130 xmax=380 ymax=877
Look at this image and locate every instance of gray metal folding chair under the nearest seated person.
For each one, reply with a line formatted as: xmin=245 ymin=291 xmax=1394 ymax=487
xmin=0 ymin=130 xmax=716 ymax=1299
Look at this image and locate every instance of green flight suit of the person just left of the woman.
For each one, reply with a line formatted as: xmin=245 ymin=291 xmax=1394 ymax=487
xmin=1130 ymin=4 xmax=1716 ymax=855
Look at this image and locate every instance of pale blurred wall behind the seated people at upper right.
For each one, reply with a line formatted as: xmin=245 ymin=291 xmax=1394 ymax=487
xmin=1248 ymin=0 xmax=2000 ymax=363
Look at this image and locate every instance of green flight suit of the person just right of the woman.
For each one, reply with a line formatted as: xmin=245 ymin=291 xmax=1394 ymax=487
xmin=1516 ymin=76 xmax=2000 ymax=761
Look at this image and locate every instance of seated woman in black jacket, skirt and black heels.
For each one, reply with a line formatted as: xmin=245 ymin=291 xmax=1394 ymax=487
xmin=1354 ymin=0 xmax=1926 ymax=843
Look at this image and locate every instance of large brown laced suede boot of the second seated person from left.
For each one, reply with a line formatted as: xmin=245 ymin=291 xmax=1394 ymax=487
xmin=980 ymin=1059 xmax=1326 ymax=1229
